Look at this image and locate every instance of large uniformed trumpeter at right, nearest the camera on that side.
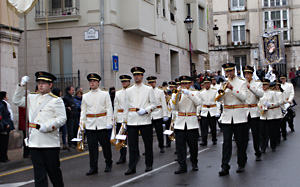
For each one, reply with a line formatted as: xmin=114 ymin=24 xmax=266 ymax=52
xmin=216 ymin=63 xmax=248 ymax=176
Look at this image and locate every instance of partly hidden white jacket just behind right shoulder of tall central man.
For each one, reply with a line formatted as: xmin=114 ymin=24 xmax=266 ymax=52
xmin=151 ymin=87 xmax=168 ymax=119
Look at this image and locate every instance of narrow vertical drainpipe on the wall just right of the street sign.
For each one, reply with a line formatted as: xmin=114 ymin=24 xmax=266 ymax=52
xmin=100 ymin=0 xmax=105 ymax=87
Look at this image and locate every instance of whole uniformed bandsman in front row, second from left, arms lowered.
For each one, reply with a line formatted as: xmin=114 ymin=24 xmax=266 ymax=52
xmin=80 ymin=73 xmax=113 ymax=175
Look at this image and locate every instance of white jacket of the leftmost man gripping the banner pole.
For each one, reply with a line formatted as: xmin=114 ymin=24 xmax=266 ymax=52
xmin=13 ymin=86 xmax=67 ymax=148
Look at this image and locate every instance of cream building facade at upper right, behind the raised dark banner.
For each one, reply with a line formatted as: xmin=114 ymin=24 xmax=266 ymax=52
xmin=208 ymin=0 xmax=300 ymax=74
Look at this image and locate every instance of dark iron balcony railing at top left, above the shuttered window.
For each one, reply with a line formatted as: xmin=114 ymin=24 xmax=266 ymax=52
xmin=35 ymin=0 xmax=79 ymax=18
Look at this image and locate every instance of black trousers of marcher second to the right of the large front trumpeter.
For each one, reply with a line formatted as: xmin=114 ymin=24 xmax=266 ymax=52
xmin=261 ymin=119 xmax=280 ymax=150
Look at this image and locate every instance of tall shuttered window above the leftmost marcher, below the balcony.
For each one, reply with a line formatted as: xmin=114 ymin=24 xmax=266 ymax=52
xmin=50 ymin=38 xmax=73 ymax=78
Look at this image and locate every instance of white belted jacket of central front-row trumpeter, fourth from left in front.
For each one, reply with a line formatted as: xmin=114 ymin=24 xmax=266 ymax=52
xmin=171 ymin=90 xmax=201 ymax=130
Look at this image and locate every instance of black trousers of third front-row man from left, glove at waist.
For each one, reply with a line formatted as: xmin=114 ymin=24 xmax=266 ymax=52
xmin=127 ymin=124 xmax=153 ymax=169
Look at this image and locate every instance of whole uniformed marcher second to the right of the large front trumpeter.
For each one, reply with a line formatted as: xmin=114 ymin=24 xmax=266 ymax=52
xmin=258 ymin=78 xmax=280 ymax=153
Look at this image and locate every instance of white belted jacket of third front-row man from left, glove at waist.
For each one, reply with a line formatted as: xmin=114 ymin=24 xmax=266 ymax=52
xmin=124 ymin=83 xmax=156 ymax=126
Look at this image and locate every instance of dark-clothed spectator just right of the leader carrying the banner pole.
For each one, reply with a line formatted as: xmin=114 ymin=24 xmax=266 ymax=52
xmin=63 ymin=86 xmax=77 ymax=148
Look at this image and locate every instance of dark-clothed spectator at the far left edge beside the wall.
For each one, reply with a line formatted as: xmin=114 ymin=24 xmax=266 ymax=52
xmin=0 ymin=91 xmax=15 ymax=162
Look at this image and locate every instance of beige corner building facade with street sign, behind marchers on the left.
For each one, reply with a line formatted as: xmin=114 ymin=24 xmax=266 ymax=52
xmin=19 ymin=0 xmax=208 ymax=90
